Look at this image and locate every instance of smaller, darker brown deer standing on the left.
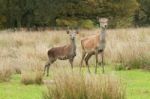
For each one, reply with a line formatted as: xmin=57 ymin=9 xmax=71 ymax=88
xmin=44 ymin=29 xmax=79 ymax=76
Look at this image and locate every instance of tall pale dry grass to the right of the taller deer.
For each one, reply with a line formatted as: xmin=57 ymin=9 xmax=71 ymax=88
xmin=105 ymin=28 xmax=150 ymax=68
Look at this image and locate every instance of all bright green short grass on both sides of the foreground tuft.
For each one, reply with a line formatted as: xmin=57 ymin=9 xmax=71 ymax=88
xmin=0 ymin=68 xmax=150 ymax=99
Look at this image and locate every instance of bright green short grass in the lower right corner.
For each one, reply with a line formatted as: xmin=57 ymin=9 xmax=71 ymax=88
xmin=116 ymin=70 xmax=150 ymax=99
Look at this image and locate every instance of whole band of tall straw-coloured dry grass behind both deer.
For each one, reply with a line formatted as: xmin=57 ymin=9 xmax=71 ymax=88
xmin=0 ymin=28 xmax=150 ymax=77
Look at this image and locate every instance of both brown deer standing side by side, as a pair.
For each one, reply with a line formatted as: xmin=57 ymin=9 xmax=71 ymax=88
xmin=44 ymin=18 xmax=108 ymax=76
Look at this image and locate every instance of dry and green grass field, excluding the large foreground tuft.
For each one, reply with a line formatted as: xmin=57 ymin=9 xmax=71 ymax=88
xmin=0 ymin=28 xmax=150 ymax=99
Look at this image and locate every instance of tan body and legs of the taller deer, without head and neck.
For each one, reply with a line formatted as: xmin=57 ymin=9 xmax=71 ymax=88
xmin=80 ymin=34 xmax=103 ymax=72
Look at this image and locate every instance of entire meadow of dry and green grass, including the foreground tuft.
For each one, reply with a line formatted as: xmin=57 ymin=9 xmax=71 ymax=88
xmin=0 ymin=28 xmax=150 ymax=99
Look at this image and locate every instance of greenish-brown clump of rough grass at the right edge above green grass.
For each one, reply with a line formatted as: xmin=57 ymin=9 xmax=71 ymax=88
xmin=116 ymin=50 xmax=150 ymax=70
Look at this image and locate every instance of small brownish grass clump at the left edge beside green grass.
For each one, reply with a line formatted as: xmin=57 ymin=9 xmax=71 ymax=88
xmin=0 ymin=69 xmax=12 ymax=82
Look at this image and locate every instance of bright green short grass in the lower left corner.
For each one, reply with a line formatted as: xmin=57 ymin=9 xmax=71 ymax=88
xmin=0 ymin=75 xmax=44 ymax=99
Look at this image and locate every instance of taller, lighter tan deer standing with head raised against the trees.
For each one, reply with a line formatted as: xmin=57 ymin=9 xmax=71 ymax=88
xmin=80 ymin=18 xmax=108 ymax=73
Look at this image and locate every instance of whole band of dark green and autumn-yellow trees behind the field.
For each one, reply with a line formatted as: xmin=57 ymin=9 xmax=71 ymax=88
xmin=0 ymin=0 xmax=150 ymax=28
